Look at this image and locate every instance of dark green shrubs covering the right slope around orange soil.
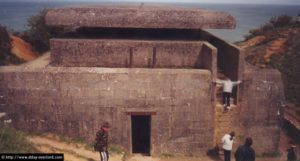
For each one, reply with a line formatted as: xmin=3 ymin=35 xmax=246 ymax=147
xmin=246 ymin=15 xmax=300 ymax=106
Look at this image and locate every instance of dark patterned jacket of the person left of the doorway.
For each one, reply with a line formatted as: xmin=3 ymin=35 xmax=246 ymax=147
xmin=94 ymin=128 xmax=108 ymax=152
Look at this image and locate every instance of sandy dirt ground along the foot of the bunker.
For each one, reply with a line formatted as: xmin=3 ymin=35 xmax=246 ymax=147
xmin=28 ymin=131 xmax=300 ymax=161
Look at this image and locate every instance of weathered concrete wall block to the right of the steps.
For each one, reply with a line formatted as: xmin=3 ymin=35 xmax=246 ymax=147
xmin=240 ymin=66 xmax=285 ymax=154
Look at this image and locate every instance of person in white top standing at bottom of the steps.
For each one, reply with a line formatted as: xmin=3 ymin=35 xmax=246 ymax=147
xmin=221 ymin=131 xmax=235 ymax=161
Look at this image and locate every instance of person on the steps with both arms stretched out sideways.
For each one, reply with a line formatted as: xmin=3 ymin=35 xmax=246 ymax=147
xmin=216 ymin=78 xmax=241 ymax=110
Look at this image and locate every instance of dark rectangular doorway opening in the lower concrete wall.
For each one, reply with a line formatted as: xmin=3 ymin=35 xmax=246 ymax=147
xmin=131 ymin=115 xmax=151 ymax=155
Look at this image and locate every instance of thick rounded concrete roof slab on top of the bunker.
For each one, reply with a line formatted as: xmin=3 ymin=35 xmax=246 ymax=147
xmin=46 ymin=4 xmax=236 ymax=29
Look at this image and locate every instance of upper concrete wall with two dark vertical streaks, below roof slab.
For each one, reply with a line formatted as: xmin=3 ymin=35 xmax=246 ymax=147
xmin=50 ymin=39 xmax=209 ymax=68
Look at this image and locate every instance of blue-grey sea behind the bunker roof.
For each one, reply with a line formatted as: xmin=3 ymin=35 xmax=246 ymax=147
xmin=0 ymin=0 xmax=300 ymax=42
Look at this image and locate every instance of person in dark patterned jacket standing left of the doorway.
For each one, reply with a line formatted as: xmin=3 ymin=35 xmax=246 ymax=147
xmin=94 ymin=122 xmax=110 ymax=161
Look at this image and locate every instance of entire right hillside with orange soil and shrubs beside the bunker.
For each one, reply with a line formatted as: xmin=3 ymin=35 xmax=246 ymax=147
xmin=237 ymin=22 xmax=300 ymax=144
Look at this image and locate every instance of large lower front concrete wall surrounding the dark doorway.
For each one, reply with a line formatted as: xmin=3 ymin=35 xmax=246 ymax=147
xmin=0 ymin=67 xmax=214 ymax=154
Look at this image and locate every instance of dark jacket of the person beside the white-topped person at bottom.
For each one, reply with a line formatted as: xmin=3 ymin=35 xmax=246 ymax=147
xmin=234 ymin=145 xmax=255 ymax=161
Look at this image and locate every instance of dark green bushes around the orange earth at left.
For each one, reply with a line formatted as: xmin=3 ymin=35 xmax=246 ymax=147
xmin=0 ymin=9 xmax=70 ymax=65
